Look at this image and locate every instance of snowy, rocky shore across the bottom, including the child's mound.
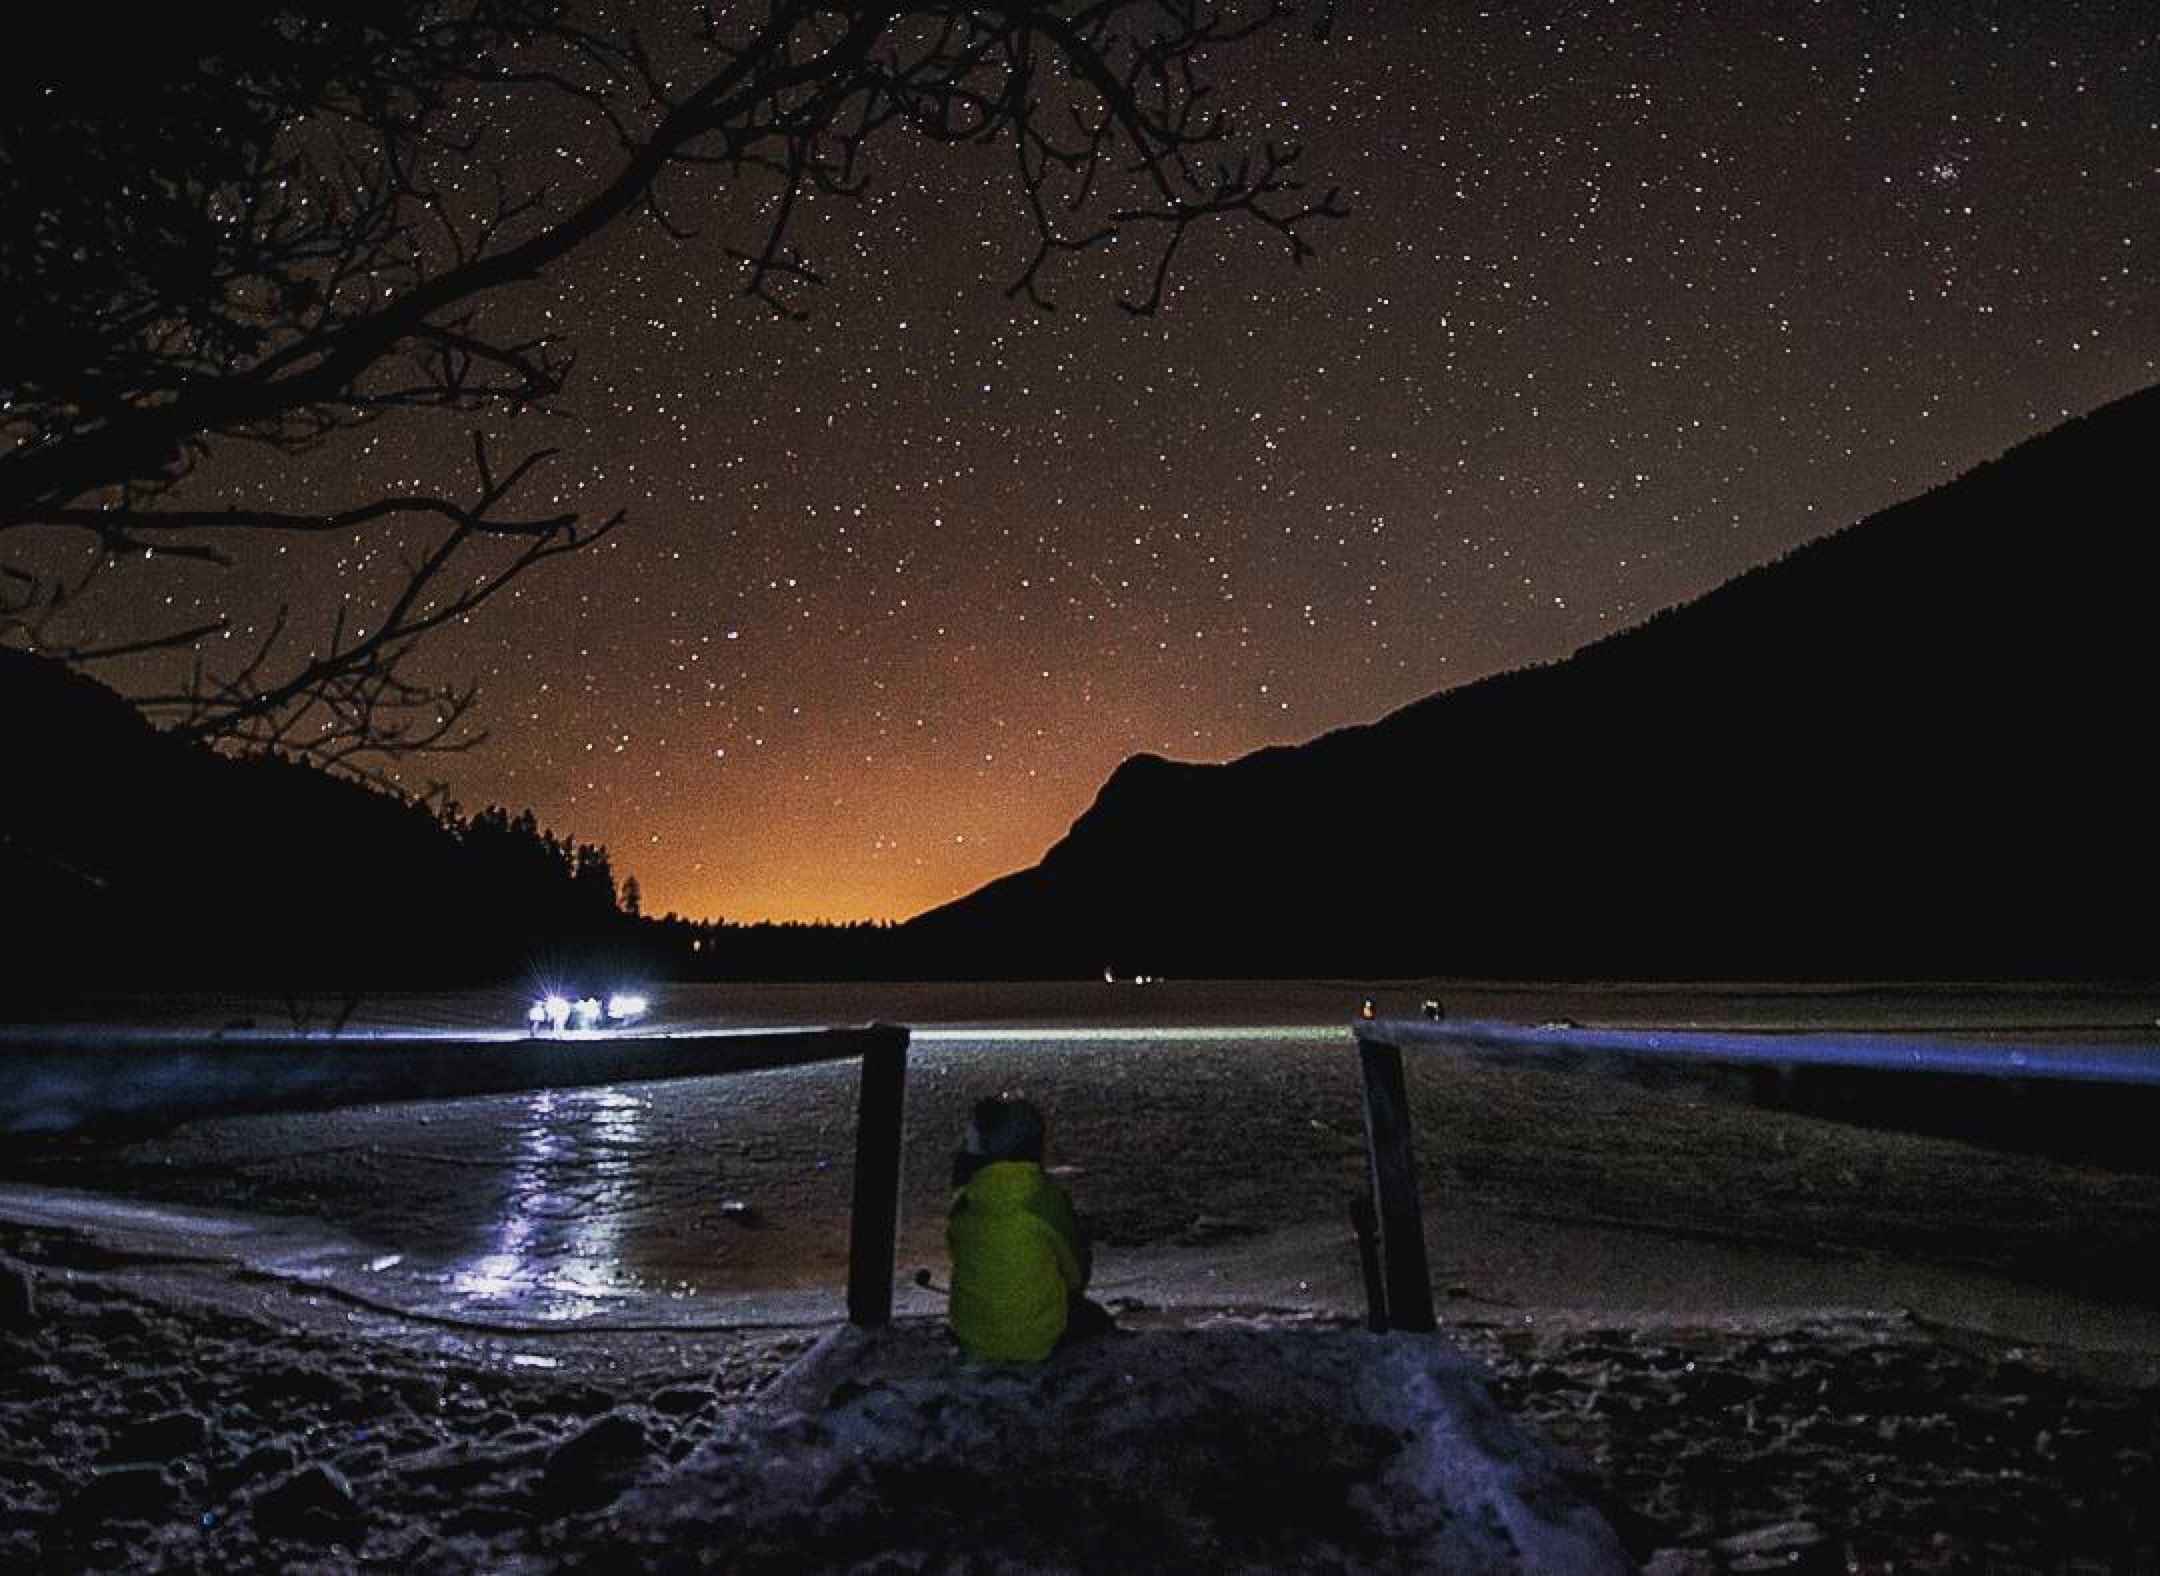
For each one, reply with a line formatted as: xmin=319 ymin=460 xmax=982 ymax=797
xmin=0 ymin=1235 xmax=2160 ymax=1574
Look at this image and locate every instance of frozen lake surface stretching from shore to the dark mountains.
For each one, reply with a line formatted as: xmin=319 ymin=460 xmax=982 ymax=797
xmin=0 ymin=982 xmax=2160 ymax=1343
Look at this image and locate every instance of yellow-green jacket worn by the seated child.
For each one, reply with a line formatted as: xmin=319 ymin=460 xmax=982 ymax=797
xmin=946 ymin=1159 xmax=1091 ymax=1362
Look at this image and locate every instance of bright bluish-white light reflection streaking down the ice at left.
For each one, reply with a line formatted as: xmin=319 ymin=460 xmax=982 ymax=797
xmin=447 ymin=1088 xmax=646 ymax=1319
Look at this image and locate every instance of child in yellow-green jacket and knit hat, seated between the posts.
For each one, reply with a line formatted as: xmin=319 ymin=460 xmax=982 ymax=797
xmin=946 ymin=1099 xmax=1110 ymax=1362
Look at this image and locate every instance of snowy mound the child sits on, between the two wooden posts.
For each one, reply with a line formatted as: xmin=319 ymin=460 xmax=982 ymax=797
xmin=609 ymin=1326 xmax=1631 ymax=1574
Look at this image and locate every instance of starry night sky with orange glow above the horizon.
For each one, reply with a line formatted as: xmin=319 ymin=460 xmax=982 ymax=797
xmin=105 ymin=0 xmax=2160 ymax=920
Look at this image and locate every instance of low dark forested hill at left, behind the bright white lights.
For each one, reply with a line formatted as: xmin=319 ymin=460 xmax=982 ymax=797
xmin=0 ymin=650 xmax=631 ymax=993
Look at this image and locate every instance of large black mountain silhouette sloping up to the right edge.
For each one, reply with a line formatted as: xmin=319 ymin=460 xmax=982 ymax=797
xmin=901 ymin=389 xmax=2160 ymax=978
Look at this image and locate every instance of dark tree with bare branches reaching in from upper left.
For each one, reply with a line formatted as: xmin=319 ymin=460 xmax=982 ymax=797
xmin=0 ymin=0 xmax=1339 ymax=766
